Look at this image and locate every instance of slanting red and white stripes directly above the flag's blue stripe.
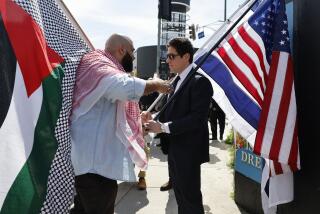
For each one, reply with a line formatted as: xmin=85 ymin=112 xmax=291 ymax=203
xmin=217 ymin=23 xmax=269 ymax=106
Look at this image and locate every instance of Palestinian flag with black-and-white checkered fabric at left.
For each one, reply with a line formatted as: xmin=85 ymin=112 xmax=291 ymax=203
xmin=0 ymin=0 xmax=89 ymax=214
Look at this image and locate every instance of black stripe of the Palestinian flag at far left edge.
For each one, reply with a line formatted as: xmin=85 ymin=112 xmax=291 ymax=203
xmin=0 ymin=14 xmax=17 ymax=128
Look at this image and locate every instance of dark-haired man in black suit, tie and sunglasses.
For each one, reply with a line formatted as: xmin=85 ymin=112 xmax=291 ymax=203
xmin=142 ymin=38 xmax=213 ymax=214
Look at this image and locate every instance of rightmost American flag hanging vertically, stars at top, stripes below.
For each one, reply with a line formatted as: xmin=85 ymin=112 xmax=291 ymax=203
xmin=249 ymin=1 xmax=300 ymax=174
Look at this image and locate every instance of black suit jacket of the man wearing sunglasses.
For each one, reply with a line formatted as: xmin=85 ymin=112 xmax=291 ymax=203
xmin=159 ymin=70 xmax=213 ymax=164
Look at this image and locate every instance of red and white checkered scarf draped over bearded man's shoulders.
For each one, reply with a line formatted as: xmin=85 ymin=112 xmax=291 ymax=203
xmin=71 ymin=50 xmax=147 ymax=169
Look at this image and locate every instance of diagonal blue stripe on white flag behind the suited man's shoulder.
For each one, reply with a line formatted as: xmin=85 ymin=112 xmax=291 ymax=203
xmin=195 ymin=55 xmax=261 ymax=129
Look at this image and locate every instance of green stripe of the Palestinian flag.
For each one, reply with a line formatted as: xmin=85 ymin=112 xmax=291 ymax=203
xmin=0 ymin=65 xmax=64 ymax=214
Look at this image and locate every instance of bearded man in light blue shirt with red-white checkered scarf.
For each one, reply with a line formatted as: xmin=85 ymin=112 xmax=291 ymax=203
xmin=71 ymin=34 xmax=171 ymax=214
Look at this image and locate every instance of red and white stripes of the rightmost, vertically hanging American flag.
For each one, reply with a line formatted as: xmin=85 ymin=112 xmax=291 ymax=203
xmin=254 ymin=52 xmax=300 ymax=174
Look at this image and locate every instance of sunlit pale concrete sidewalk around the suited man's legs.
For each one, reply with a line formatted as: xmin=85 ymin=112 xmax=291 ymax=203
xmin=115 ymin=126 xmax=244 ymax=214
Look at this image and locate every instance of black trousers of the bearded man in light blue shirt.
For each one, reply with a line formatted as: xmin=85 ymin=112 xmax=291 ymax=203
xmin=70 ymin=173 xmax=118 ymax=214
